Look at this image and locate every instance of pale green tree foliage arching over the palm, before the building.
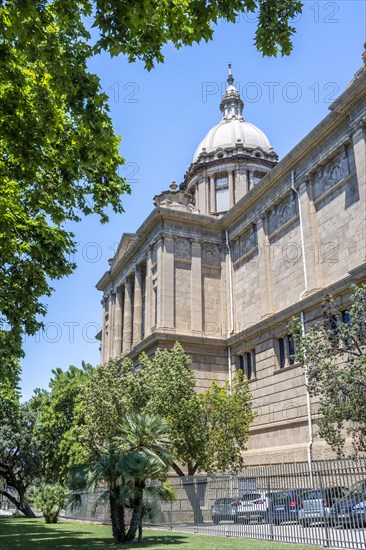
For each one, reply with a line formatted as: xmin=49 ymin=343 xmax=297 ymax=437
xmin=78 ymin=343 xmax=253 ymax=476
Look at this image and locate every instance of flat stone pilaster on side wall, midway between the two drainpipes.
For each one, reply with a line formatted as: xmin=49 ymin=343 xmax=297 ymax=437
xmin=257 ymin=214 xmax=275 ymax=317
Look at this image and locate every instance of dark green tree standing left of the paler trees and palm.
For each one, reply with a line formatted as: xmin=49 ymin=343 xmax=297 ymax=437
xmin=30 ymin=363 xmax=94 ymax=483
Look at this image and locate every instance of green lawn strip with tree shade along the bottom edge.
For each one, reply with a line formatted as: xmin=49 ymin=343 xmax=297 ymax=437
xmin=0 ymin=517 xmax=322 ymax=550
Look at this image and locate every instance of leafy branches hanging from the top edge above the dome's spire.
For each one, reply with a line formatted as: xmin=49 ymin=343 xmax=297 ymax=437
xmin=95 ymin=0 xmax=302 ymax=69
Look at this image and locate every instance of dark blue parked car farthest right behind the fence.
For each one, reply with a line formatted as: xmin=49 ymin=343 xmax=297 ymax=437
xmin=331 ymin=480 xmax=366 ymax=528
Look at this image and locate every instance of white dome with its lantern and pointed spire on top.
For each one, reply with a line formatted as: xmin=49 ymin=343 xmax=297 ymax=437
xmin=192 ymin=63 xmax=272 ymax=162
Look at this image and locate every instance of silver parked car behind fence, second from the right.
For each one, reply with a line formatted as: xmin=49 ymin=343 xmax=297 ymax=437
xmin=298 ymin=487 xmax=348 ymax=527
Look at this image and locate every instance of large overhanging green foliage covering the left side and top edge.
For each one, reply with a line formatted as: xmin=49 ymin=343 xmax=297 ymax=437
xmin=0 ymin=0 xmax=302 ymax=394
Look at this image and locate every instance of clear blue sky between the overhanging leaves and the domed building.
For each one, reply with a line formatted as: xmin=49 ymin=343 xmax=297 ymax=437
xmin=22 ymin=0 xmax=366 ymax=399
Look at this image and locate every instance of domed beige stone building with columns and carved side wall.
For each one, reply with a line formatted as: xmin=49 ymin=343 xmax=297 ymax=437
xmin=97 ymin=53 xmax=366 ymax=464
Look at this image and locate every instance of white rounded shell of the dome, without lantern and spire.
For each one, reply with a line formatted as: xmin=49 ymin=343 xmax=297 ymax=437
xmin=192 ymin=117 xmax=272 ymax=162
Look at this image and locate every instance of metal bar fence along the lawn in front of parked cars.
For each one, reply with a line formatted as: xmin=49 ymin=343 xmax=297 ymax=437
xmin=68 ymin=457 xmax=366 ymax=550
